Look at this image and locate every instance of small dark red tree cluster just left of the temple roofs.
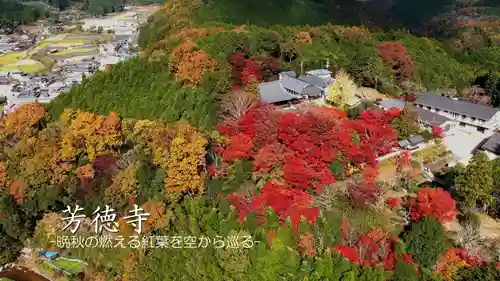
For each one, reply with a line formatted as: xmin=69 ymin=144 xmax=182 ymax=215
xmin=229 ymin=52 xmax=281 ymax=87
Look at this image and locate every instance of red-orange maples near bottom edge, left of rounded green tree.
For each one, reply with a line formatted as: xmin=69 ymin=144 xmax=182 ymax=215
xmin=331 ymin=221 xmax=414 ymax=270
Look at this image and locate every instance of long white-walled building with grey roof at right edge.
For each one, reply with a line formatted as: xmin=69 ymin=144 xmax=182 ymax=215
xmin=415 ymin=93 xmax=500 ymax=135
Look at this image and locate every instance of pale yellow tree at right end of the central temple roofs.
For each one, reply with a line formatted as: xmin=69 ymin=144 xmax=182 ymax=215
xmin=326 ymin=70 xmax=357 ymax=108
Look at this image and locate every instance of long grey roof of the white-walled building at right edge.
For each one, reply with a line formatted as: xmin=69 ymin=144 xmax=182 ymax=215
xmin=415 ymin=93 xmax=498 ymax=120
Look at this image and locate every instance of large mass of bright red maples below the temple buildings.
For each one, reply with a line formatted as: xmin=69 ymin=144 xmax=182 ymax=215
xmin=220 ymin=105 xmax=399 ymax=229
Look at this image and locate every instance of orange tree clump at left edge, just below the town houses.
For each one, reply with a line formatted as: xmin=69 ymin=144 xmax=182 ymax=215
xmin=0 ymin=102 xmax=45 ymax=140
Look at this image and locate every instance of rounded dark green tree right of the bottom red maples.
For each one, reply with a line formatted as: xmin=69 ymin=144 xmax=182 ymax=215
xmin=403 ymin=217 xmax=449 ymax=267
